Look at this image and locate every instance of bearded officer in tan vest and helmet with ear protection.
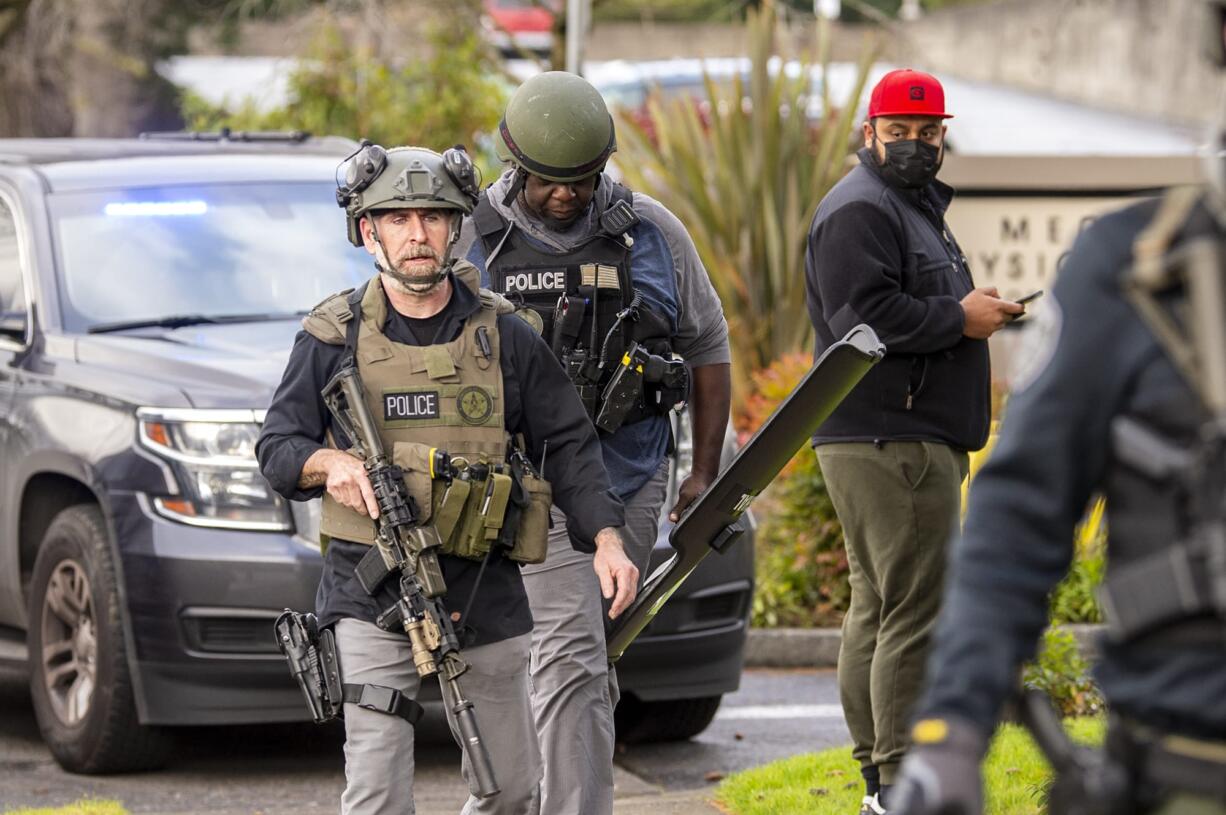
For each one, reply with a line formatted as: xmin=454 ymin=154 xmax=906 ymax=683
xmin=256 ymin=145 xmax=638 ymax=815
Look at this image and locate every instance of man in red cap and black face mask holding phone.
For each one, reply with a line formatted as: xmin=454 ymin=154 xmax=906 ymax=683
xmin=805 ymin=69 xmax=1022 ymax=815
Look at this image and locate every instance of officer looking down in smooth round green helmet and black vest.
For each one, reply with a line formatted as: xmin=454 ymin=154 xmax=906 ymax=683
xmin=456 ymin=71 xmax=729 ymax=815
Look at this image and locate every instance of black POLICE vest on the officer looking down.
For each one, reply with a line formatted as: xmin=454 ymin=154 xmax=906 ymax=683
xmin=472 ymin=184 xmax=688 ymax=429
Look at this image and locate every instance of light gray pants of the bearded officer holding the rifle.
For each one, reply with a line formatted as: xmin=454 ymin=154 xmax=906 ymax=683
xmin=336 ymin=619 xmax=541 ymax=815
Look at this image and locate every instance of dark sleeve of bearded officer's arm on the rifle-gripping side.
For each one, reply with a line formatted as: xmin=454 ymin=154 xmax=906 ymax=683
xmin=255 ymin=331 xmax=345 ymax=501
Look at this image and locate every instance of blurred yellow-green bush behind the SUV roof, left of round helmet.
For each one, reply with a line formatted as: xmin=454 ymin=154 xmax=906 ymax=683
xmin=183 ymin=14 xmax=510 ymax=178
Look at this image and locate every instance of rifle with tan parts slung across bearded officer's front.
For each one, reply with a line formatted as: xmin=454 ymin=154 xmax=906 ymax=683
xmin=322 ymin=366 xmax=499 ymax=798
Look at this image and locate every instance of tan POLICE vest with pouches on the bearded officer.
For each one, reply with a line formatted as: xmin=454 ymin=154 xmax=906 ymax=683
xmin=303 ymin=263 xmax=552 ymax=563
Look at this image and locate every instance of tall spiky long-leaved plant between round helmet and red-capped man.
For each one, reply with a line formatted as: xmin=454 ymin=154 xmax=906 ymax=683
xmin=617 ymin=2 xmax=873 ymax=403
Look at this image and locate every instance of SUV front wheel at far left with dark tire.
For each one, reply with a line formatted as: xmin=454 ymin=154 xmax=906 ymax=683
xmin=26 ymin=505 xmax=167 ymax=773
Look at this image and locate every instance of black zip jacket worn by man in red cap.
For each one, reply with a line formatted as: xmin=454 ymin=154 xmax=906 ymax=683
xmin=804 ymin=148 xmax=991 ymax=450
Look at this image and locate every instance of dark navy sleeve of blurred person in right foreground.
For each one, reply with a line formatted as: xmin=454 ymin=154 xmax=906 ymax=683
xmin=920 ymin=203 xmax=1156 ymax=732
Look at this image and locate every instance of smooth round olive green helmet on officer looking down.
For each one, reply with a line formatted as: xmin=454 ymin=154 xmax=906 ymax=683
xmin=494 ymin=71 xmax=617 ymax=183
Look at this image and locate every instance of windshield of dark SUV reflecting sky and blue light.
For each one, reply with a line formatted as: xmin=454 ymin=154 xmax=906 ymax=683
xmin=50 ymin=183 xmax=373 ymax=331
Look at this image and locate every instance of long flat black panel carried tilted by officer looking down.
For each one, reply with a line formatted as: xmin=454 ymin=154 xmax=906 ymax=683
xmin=607 ymin=325 xmax=885 ymax=662
